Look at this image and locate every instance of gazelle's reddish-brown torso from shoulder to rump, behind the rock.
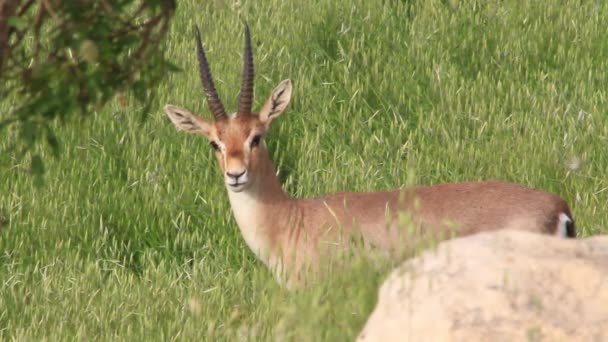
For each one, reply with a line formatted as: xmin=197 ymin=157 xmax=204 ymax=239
xmin=298 ymin=181 xmax=575 ymax=251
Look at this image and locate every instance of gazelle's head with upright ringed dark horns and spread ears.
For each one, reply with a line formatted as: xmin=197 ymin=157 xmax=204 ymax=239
xmin=164 ymin=24 xmax=291 ymax=192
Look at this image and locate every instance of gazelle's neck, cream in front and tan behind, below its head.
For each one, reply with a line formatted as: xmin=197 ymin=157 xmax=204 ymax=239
xmin=227 ymin=146 xmax=292 ymax=268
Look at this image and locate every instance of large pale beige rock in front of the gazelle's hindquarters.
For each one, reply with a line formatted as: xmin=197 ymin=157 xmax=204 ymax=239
xmin=358 ymin=230 xmax=608 ymax=342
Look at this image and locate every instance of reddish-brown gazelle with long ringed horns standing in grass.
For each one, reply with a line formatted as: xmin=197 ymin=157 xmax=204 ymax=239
xmin=164 ymin=25 xmax=576 ymax=285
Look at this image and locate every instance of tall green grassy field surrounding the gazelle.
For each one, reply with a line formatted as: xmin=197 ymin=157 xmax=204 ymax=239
xmin=0 ymin=0 xmax=608 ymax=341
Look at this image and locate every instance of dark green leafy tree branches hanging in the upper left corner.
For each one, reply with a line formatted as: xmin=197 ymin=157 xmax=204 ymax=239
xmin=0 ymin=0 xmax=175 ymax=174
